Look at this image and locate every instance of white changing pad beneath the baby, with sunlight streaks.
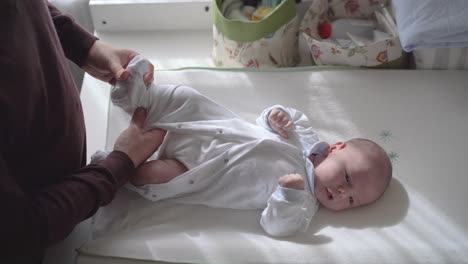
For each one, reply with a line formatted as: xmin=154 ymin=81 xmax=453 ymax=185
xmin=77 ymin=68 xmax=468 ymax=264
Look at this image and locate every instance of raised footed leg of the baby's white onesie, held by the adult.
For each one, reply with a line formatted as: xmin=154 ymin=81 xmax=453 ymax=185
xmin=111 ymin=55 xmax=238 ymax=130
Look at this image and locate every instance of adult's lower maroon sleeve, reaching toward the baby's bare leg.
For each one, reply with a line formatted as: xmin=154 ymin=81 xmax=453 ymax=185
xmin=0 ymin=151 xmax=134 ymax=256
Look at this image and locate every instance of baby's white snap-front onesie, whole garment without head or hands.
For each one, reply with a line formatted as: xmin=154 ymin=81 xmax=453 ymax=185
xmin=111 ymin=57 xmax=327 ymax=236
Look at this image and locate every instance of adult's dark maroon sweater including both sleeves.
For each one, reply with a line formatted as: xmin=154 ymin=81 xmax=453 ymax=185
xmin=0 ymin=0 xmax=135 ymax=263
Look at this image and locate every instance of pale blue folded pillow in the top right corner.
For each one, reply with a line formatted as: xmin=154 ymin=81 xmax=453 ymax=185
xmin=393 ymin=0 xmax=468 ymax=52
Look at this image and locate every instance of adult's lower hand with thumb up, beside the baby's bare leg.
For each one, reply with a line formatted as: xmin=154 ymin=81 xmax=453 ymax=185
xmin=114 ymin=108 xmax=166 ymax=167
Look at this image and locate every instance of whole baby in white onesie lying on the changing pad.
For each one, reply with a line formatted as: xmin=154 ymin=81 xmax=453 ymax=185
xmin=98 ymin=57 xmax=392 ymax=236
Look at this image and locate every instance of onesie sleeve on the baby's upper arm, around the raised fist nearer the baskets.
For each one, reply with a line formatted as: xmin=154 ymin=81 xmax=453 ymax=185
xmin=256 ymin=105 xmax=319 ymax=151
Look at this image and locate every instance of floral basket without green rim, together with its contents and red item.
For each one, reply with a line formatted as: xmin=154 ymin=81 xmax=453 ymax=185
xmin=300 ymin=0 xmax=406 ymax=67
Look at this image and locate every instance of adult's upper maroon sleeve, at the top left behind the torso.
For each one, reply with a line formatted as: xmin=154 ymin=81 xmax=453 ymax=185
xmin=47 ymin=3 xmax=97 ymax=67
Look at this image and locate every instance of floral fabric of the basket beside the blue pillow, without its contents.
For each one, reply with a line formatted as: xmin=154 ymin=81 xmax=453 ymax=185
xmin=300 ymin=0 xmax=406 ymax=67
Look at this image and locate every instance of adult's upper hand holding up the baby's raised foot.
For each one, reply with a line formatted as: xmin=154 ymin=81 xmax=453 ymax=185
xmin=82 ymin=40 xmax=154 ymax=86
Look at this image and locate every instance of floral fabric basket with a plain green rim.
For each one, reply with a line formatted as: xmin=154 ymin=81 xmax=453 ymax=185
xmin=212 ymin=0 xmax=300 ymax=68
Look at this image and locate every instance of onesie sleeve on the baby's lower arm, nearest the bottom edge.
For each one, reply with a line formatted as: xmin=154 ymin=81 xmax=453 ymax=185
xmin=260 ymin=186 xmax=318 ymax=237
